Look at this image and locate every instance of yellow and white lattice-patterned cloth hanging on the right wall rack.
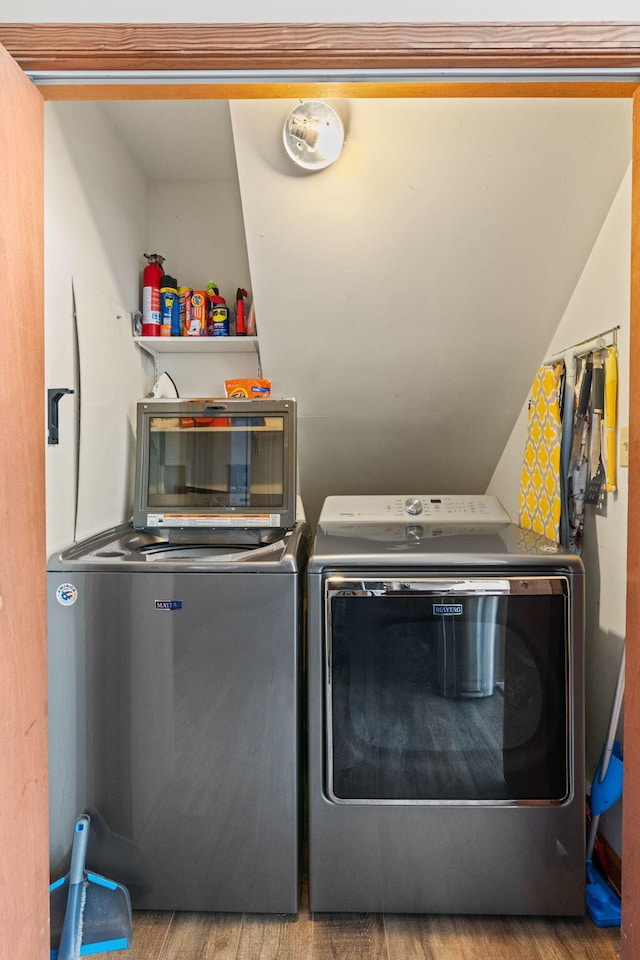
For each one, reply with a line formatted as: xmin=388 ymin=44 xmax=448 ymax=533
xmin=518 ymin=363 xmax=564 ymax=543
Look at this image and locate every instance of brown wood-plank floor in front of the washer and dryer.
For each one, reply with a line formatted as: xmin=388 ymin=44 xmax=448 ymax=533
xmin=100 ymin=894 xmax=620 ymax=960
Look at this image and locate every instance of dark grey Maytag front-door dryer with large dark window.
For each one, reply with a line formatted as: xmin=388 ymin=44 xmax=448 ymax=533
xmin=308 ymin=496 xmax=585 ymax=915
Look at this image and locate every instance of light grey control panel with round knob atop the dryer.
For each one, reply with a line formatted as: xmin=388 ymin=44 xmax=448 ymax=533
xmin=319 ymin=494 xmax=511 ymax=524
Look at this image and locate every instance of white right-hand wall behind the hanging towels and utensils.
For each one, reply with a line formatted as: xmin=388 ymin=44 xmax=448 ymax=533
xmin=488 ymin=169 xmax=631 ymax=846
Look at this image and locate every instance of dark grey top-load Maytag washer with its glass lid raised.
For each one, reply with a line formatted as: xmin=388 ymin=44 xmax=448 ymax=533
xmin=47 ymin=399 xmax=309 ymax=913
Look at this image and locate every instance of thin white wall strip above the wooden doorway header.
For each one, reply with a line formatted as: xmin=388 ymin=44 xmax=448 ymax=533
xmin=0 ymin=0 xmax=638 ymax=23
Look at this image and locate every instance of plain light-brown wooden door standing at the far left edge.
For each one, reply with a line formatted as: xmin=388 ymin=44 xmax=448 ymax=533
xmin=0 ymin=37 xmax=49 ymax=958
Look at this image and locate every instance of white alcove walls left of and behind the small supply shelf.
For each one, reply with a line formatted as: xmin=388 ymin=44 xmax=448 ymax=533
xmin=45 ymin=103 xmax=272 ymax=554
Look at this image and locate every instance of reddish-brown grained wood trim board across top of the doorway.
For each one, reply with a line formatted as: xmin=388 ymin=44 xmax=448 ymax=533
xmin=0 ymin=21 xmax=640 ymax=71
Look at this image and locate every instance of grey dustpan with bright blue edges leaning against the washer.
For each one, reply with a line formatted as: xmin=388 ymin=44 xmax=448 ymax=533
xmin=49 ymin=814 xmax=132 ymax=960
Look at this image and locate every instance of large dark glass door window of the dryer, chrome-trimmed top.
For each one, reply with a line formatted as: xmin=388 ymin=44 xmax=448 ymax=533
xmin=326 ymin=577 xmax=570 ymax=803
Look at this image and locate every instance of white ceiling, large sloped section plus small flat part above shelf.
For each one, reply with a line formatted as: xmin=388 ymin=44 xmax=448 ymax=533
xmin=102 ymin=99 xmax=631 ymax=521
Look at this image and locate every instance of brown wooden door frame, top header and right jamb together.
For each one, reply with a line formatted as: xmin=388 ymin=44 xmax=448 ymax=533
xmin=0 ymin=22 xmax=640 ymax=960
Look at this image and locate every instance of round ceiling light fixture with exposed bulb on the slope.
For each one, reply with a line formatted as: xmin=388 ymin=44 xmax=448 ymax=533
xmin=283 ymin=100 xmax=344 ymax=170
